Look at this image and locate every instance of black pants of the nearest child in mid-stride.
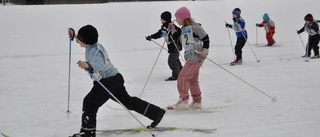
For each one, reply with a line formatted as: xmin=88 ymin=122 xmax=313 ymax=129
xmin=80 ymin=73 xmax=161 ymax=137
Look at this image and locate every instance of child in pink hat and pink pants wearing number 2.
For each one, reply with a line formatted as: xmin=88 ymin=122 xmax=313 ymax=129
xmin=167 ymin=7 xmax=210 ymax=109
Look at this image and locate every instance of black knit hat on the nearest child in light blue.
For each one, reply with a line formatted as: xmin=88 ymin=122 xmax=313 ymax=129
xmin=77 ymin=25 xmax=98 ymax=45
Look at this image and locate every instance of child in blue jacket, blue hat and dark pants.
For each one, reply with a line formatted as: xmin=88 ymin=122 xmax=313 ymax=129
xmin=226 ymin=8 xmax=248 ymax=66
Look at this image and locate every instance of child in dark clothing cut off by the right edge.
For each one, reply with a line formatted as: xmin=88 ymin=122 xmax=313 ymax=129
xmin=297 ymin=13 xmax=320 ymax=59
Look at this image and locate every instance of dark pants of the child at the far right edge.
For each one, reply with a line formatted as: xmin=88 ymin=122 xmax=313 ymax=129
xmin=306 ymin=35 xmax=320 ymax=57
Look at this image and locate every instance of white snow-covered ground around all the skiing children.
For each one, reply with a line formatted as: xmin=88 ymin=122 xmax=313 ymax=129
xmin=0 ymin=0 xmax=320 ymax=137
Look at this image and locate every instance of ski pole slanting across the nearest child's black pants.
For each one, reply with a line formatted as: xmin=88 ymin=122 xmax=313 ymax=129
xmin=87 ymin=71 xmax=155 ymax=137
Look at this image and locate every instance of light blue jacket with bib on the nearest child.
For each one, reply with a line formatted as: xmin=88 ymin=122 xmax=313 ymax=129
xmin=85 ymin=43 xmax=119 ymax=79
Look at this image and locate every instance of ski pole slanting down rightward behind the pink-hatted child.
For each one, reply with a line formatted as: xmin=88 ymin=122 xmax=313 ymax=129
xmin=195 ymin=51 xmax=277 ymax=103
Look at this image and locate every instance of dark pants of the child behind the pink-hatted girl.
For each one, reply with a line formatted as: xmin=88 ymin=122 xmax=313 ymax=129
xmin=168 ymin=52 xmax=182 ymax=78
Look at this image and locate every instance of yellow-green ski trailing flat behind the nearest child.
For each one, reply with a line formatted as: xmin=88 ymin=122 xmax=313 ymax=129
xmin=96 ymin=127 xmax=217 ymax=134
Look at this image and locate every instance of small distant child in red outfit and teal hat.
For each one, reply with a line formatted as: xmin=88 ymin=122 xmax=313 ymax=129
xmin=256 ymin=13 xmax=275 ymax=46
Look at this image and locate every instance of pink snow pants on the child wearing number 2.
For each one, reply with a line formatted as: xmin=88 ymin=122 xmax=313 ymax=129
xmin=177 ymin=61 xmax=203 ymax=102
